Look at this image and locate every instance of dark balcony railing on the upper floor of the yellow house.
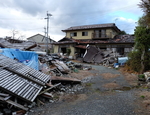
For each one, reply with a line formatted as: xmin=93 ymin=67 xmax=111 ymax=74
xmin=92 ymin=33 xmax=112 ymax=39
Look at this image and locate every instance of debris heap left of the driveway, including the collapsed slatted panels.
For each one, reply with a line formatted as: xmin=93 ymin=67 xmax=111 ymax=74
xmin=0 ymin=54 xmax=91 ymax=115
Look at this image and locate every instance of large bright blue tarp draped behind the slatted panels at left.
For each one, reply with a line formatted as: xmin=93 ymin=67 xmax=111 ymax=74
xmin=0 ymin=48 xmax=39 ymax=70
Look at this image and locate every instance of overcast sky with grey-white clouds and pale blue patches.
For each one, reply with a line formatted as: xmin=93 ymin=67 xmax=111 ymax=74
xmin=0 ymin=0 xmax=143 ymax=41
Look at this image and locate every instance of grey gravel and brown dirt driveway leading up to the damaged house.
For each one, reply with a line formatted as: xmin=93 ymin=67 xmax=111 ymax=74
xmin=29 ymin=66 xmax=150 ymax=115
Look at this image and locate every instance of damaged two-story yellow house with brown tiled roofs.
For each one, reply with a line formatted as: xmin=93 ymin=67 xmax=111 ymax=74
xmin=54 ymin=23 xmax=134 ymax=57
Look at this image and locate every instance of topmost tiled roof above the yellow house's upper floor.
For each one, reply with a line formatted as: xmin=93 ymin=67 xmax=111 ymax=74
xmin=62 ymin=23 xmax=120 ymax=32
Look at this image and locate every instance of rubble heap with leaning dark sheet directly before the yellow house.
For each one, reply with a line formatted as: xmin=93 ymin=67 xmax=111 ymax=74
xmin=83 ymin=46 xmax=128 ymax=66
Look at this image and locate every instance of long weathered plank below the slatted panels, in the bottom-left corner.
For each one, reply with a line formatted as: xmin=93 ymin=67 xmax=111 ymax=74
xmin=0 ymin=97 xmax=28 ymax=111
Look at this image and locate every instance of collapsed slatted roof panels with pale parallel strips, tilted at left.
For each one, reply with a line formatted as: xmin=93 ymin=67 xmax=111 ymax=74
xmin=0 ymin=54 xmax=51 ymax=102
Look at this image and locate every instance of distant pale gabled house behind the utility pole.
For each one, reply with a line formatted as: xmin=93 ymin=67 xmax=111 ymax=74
xmin=27 ymin=34 xmax=55 ymax=51
